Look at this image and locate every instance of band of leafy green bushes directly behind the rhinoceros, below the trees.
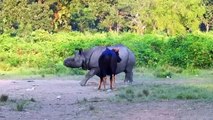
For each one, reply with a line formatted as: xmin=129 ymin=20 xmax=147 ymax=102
xmin=0 ymin=31 xmax=213 ymax=73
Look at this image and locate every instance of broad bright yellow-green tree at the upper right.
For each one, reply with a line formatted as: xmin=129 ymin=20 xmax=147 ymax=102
xmin=136 ymin=0 xmax=205 ymax=35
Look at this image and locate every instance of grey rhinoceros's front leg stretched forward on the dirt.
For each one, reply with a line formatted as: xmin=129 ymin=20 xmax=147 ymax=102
xmin=80 ymin=68 xmax=99 ymax=86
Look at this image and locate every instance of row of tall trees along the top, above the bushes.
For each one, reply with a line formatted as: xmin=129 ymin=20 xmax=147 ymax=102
xmin=0 ymin=0 xmax=213 ymax=36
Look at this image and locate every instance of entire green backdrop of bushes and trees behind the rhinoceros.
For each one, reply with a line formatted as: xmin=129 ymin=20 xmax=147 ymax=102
xmin=0 ymin=0 xmax=213 ymax=73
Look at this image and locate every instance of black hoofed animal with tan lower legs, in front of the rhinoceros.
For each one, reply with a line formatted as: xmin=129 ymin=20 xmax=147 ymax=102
xmin=98 ymin=48 xmax=121 ymax=90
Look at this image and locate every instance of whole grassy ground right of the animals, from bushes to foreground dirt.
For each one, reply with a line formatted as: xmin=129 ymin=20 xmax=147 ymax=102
xmin=115 ymin=66 xmax=213 ymax=102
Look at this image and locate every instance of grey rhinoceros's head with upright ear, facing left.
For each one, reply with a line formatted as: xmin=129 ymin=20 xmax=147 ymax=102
xmin=64 ymin=48 xmax=85 ymax=68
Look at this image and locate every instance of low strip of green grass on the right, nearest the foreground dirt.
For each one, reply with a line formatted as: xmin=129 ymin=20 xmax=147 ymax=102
xmin=113 ymin=84 xmax=213 ymax=102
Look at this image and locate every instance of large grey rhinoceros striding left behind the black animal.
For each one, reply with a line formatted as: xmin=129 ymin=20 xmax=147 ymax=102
xmin=64 ymin=44 xmax=135 ymax=86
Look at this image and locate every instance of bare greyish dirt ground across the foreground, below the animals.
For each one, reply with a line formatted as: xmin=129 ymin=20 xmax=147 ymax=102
xmin=0 ymin=76 xmax=213 ymax=120
